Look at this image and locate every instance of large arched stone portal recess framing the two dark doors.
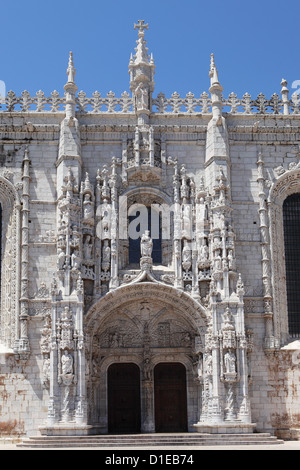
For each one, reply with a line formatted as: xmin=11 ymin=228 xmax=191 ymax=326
xmin=85 ymin=282 xmax=206 ymax=433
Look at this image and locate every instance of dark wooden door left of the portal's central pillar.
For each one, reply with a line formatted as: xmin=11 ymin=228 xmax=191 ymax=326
xmin=107 ymin=363 xmax=141 ymax=434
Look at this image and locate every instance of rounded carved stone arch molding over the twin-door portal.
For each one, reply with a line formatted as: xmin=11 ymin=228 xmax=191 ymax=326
xmin=85 ymin=282 xmax=209 ymax=342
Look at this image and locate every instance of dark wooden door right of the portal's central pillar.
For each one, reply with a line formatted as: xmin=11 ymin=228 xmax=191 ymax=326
xmin=154 ymin=363 xmax=187 ymax=432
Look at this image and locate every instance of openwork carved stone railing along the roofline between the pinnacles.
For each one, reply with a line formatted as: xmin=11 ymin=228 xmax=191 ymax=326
xmin=0 ymin=90 xmax=300 ymax=115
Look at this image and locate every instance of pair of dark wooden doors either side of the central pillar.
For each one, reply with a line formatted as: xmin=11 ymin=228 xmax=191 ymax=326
xmin=108 ymin=363 xmax=187 ymax=434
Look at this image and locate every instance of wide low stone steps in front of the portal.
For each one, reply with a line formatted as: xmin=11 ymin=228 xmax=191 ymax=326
xmin=18 ymin=433 xmax=284 ymax=448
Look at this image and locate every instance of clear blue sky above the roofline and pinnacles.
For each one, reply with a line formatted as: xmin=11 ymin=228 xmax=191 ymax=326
xmin=0 ymin=0 xmax=300 ymax=97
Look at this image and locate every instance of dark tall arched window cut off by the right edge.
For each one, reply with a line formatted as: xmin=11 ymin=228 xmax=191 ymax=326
xmin=283 ymin=193 xmax=300 ymax=337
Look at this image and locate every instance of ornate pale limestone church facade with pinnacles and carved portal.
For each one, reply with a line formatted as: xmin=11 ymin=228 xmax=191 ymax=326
xmin=0 ymin=21 xmax=300 ymax=437
